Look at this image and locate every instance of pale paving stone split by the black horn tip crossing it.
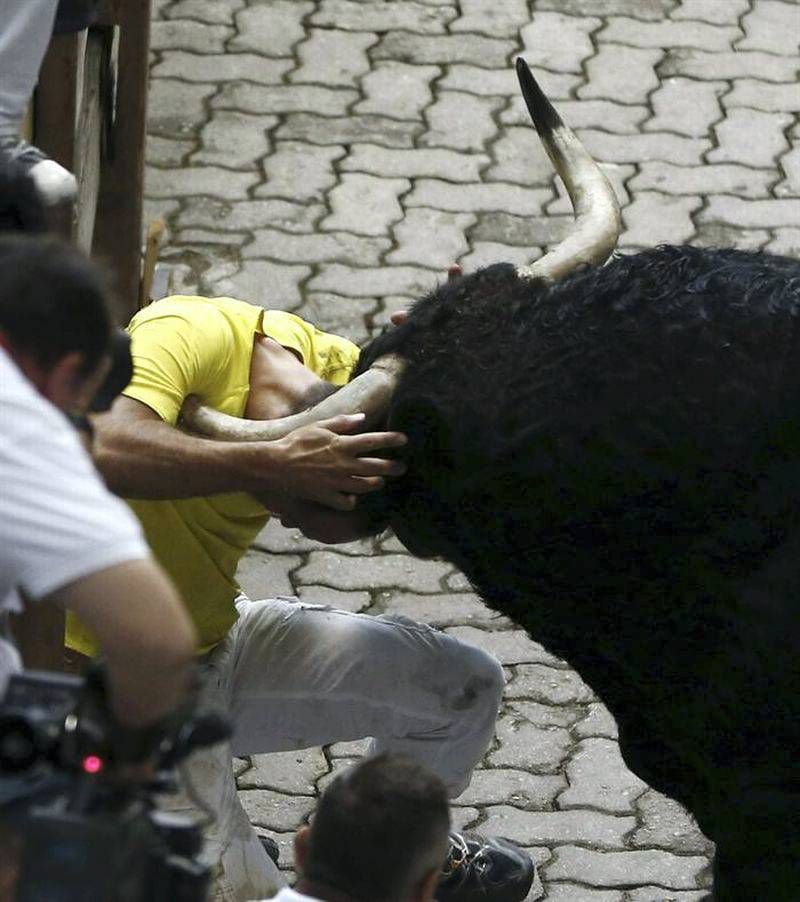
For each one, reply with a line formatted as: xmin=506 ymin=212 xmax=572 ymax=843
xmin=438 ymin=66 xmax=583 ymax=103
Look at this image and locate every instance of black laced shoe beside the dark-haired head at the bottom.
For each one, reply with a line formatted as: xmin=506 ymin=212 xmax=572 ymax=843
xmin=436 ymin=833 xmax=536 ymax=902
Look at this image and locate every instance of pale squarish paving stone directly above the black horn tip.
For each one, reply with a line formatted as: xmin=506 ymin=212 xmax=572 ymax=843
xmin=519 ymin=10 xmax=603 ymax=73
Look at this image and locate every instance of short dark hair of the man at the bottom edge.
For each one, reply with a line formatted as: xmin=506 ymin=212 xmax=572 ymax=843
xmin=303 ymin=754 xmax=450 ymax=902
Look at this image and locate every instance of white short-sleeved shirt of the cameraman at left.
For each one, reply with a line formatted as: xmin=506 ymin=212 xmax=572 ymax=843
xmin=0 ymin=348 xmax=148 ymax=697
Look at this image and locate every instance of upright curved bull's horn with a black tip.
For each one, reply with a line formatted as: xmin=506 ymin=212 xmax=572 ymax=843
xmin=517 ymin=57 xmax=621 ymax=281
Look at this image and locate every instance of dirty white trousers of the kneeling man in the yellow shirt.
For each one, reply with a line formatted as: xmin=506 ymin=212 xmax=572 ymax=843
xmin=170 ymin=598 xmax=504 ymax=902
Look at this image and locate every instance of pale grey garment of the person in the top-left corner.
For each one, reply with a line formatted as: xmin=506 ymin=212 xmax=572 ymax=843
xmin=0 ymin=0 xmax=58 ymax=143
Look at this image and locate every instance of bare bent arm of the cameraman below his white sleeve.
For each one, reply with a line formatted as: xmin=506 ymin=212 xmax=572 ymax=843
xmin=52 ymin=559 xmax=196 ymax=727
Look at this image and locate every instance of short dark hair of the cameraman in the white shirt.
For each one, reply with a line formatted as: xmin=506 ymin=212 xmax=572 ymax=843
xmin=0 ymin=235 xmax=113 ymax=373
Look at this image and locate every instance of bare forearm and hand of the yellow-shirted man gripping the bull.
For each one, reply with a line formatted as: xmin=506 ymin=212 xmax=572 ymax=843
xmin=94 ymin=396 xmax=405 ymax=510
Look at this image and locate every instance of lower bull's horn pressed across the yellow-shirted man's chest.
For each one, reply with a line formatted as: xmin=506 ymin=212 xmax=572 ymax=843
xmin=180 ymin=354 xmax=403 ymax=442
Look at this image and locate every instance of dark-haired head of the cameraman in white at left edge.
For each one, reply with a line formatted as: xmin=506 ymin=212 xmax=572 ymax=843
xmin=0 ymin=234 xmax=113 ymax=413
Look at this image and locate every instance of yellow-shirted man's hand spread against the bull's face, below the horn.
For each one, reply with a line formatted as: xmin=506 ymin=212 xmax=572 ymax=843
xmin=250 ymin=414 xmax=406 ymax=511
